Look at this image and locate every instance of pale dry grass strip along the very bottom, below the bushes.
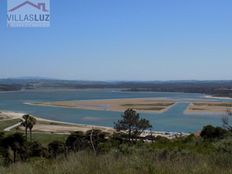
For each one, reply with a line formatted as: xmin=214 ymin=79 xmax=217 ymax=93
xmin=0 ymin=152 xmax=232 ymax=174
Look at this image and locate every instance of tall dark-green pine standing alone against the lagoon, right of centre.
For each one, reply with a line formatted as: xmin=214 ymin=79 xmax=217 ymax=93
xmin=114 ymin=109 xmax=152 ymax=141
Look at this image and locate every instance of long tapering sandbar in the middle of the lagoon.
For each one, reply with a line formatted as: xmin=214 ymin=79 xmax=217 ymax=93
xmin=33 ymin=98 xmax=175 ymax=113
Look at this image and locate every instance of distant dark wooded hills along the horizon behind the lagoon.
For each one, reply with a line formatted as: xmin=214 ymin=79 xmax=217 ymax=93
xmin=0 ymin=78 xmax=232 ymax=97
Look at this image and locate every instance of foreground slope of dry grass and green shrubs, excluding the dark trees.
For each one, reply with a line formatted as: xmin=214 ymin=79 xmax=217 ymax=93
xmin=0 ymin=128 xmax=232 ymax=174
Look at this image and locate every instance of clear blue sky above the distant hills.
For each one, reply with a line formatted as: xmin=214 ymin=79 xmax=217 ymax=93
xmin=0 ymin=0 xmax=232 ymax=81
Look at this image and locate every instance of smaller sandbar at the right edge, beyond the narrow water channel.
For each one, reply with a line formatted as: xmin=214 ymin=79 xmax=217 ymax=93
xmin=187 ymin=102 xmax=232 ymax=114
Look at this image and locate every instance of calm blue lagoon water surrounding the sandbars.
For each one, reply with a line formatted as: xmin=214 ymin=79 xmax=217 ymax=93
xmin=0 ymin=89 xmax=232 ymax=132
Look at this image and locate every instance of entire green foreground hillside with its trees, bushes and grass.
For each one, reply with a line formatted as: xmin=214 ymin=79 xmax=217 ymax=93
xmin=0 ymin=109 xmax=232 ymax=174
